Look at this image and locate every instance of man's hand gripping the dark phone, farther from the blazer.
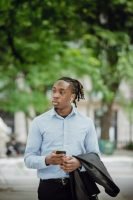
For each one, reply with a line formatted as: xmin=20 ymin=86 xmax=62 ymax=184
xmin=45 ymin=151 xmax=65 ymax=165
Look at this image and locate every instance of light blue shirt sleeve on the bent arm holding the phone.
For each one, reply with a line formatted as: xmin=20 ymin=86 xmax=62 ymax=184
xmin=24 ymin=120 xmax=47 ymax=169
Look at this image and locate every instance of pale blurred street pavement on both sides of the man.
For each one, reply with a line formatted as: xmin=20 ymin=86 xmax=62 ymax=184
xmin=0 ymin=150 xmax=133 ymax=200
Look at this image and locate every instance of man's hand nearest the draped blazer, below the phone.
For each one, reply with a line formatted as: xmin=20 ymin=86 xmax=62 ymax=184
xmin=60 ymin=156 xmax=81 ymax=172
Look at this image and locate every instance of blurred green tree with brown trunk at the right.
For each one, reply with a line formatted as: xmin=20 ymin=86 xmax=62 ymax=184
xmin=71 ymin=0 xmax=133 ymax=139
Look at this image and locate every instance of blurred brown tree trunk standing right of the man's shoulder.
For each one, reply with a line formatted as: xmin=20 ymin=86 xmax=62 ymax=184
xmin=100 ymin=104 xmax=112 ymax=140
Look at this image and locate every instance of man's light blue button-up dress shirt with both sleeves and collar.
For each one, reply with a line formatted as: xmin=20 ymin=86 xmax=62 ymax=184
xmin=24 ymin=106 xmax=99 ymax=179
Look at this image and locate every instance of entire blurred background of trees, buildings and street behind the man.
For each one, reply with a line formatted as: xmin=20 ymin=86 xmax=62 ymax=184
xmin=0 ymin=0 xmax=133 ymax=200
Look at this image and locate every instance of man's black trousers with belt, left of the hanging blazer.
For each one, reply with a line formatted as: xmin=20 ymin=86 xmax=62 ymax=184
xmin=38 ymin=180 xmax=72 ymax=200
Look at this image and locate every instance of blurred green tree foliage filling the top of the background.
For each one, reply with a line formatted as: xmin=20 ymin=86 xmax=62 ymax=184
xmin=0 ymin=0 xmax=133 ymax=119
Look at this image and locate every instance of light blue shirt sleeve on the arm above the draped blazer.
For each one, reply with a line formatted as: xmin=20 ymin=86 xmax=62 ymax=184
xmin=85 ymin=118 xmax=100 ymax=155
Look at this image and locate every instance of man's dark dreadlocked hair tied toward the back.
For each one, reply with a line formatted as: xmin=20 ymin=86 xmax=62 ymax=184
xmin=58 ymin=77 xmax=84 ymax=107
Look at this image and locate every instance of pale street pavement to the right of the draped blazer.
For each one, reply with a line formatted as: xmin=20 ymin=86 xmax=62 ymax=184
xmin=101 ymin=156 xmax=133 ymax=200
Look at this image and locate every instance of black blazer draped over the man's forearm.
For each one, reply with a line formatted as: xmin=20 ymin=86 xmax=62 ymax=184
xmin=70 ymin=153 xmax=120 ymax=200
